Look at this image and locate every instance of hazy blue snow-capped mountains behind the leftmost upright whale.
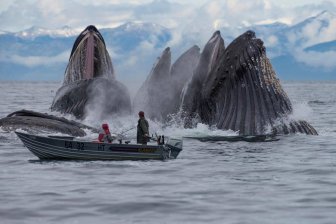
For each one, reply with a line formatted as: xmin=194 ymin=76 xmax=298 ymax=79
xmin=0 ymin=22 xmax=171 ymax=80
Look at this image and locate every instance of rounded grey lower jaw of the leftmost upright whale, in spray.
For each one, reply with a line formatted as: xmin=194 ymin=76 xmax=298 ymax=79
xmin=51 ymin=78 xmax=131 ymax=119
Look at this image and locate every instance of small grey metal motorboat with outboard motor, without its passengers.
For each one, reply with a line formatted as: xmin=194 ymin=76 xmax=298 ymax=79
xmin=15 ymin=132 xmax=182 ymax=160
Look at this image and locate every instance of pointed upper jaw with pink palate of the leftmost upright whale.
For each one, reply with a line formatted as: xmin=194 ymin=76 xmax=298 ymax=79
xmin=64 ymin=25 xmax=113 ymax=84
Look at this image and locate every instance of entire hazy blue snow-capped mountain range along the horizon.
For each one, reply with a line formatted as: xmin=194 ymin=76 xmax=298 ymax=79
xmin=0 ymin=11 xmax=336 ymax=82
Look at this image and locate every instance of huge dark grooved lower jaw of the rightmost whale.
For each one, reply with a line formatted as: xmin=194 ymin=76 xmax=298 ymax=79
xmin=195 ymin=31 xmax=317 ymax=135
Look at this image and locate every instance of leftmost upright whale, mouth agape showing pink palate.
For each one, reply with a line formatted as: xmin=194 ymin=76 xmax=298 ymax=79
xmin=51 ymin=25 xmax=131 ymax=119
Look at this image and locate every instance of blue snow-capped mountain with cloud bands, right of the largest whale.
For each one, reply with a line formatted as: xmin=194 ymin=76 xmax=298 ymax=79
xmin=254 ymin=11 xmax=336 ymax=79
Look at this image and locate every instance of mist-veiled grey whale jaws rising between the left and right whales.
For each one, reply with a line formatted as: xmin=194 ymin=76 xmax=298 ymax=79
xmin=133 ymin=46 xmax=200 ymax=121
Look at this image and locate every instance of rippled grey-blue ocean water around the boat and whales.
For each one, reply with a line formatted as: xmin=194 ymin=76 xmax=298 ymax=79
xmin=0 ymin=82 xmax=336 ymax=224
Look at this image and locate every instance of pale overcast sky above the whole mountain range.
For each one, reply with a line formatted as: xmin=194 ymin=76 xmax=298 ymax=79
xmin=0 ymin=0 xmax=336 ymax=32
